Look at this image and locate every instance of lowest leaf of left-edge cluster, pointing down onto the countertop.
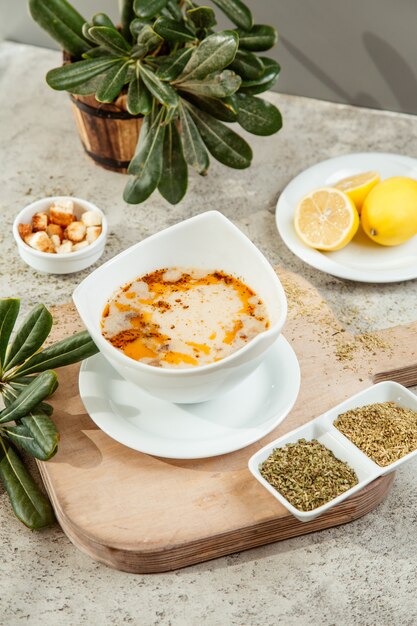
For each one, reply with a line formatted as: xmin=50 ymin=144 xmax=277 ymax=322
xmin=0 ymin=438 xmax=55 ymax=529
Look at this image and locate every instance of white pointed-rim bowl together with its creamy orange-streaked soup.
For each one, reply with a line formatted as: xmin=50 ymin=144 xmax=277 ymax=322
xmin=73 ymin=211 xmax=287 ymax=403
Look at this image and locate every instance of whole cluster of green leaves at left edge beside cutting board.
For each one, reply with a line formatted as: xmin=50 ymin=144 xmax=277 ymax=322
xmin=0 ymin=298 xmax=98 ymax=529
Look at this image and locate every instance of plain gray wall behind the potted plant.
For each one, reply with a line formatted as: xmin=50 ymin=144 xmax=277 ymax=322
xmin=0 ymin=0 xmax=417 ymax=113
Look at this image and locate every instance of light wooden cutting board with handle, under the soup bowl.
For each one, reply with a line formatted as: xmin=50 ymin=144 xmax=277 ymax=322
xmin=38 ymin=269 xmax=417 ymax=573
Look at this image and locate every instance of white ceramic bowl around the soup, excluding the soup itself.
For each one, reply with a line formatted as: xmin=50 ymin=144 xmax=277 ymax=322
xmin=73 ymin=211 xmax=287 ymax=403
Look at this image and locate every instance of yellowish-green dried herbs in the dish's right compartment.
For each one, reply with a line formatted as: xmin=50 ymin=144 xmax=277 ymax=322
xmin=334 ymin=402 xmax=417 ymax=467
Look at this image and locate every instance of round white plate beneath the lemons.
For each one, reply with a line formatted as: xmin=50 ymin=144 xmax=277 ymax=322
xmin=276 ymin=152 xmax=417 ymax=283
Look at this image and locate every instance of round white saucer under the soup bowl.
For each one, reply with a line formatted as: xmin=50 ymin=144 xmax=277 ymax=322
xmin=79 ymin=336 xmax=300 ymax=459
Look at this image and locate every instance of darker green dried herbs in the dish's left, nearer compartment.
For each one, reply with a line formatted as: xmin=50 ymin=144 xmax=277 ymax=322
xmin=259 ymin=439 xmax=358 ymax=511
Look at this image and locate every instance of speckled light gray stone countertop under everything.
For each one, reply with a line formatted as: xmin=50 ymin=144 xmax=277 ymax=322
xmin=0 ymin=42 xmax=417 ymax=626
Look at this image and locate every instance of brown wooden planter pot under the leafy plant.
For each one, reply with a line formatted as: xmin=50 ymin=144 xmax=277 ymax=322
xmin=70 ymin=94 xmax=143 ymax=173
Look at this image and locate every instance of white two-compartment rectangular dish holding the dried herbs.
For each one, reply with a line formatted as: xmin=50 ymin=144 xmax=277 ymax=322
xmin=248 ymin=381 xmax=417 ymax=522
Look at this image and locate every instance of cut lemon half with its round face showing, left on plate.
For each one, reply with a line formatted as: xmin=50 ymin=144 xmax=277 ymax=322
xmin=294 ymin=187 xmax=359 ymax=251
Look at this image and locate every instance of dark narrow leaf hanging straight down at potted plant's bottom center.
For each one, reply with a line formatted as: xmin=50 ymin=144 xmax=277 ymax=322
xmin=158 ymin=122 xmax=188 ymax=204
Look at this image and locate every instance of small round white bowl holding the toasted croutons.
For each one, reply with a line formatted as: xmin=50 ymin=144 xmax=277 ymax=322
xmin=13 ymin=196 xmax=107 ymax=274
